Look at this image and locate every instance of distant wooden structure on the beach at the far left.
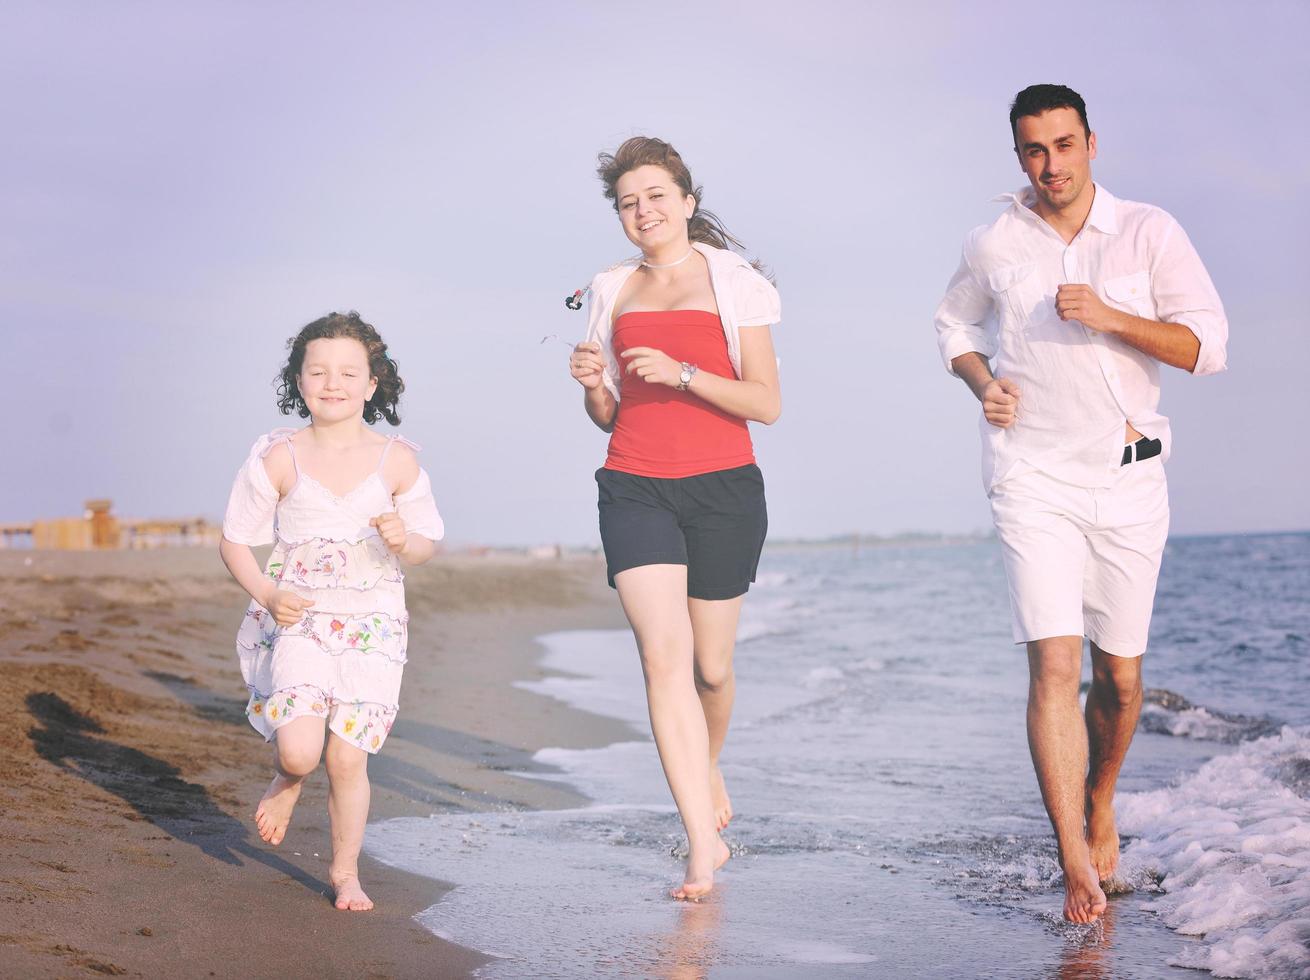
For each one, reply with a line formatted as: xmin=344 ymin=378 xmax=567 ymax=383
xmin=0 ymin=499 xmax=223 ymax=552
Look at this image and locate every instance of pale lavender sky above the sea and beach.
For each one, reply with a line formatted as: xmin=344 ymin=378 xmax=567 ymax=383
xmin=0 ymin=0 xmax=1310 ymax=545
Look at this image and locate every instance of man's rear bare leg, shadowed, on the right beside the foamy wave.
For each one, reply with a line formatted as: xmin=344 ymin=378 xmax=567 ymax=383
xmin=1086 ymin=643 xmax=1142 ymax=882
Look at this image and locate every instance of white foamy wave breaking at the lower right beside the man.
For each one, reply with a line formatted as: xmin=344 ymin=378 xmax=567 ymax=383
xmin=1117 ymin=727 xmax=1310 ymax=977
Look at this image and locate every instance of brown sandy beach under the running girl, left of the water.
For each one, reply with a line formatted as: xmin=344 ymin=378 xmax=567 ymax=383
xmin=0 ymin=549 xmax=626 ymax=977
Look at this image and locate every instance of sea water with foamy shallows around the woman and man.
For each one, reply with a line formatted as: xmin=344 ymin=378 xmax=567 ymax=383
xmin=367 ymin=535 xmax=1310 ymax=977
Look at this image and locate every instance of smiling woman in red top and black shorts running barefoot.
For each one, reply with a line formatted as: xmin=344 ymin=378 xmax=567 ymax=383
xmin=570 ymin=136 xmax=781 ymax=900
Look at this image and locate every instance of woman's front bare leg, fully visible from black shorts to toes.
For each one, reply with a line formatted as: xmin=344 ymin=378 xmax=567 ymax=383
xmin=614 ymin=565 xmax=728 ymax=899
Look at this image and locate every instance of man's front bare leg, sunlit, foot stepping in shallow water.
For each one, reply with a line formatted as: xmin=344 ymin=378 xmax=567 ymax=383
xmin=1028 ymin=637 xmax=1106 ymax=922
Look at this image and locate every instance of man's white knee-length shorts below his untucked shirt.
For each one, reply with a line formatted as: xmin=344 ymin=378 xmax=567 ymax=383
xmin=989 ymin=456 xmax=1169 ymax=656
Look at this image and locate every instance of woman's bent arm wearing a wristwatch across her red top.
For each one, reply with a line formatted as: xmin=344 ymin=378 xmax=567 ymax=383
xmin=618 ymin=326 xmax=782 ymax=426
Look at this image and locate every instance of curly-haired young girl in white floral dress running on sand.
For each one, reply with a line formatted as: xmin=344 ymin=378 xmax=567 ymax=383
xmin=219 ymin=312 xmax=443 ymax=911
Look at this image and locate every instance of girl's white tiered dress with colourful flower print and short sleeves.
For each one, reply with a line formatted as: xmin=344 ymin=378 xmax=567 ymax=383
xmin=223 ymin=428 xmax=444 ymax=752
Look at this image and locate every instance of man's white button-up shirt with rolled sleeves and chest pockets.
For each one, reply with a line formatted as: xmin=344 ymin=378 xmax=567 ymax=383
xmin=935 ymin=185 xmax=1227 ymax=491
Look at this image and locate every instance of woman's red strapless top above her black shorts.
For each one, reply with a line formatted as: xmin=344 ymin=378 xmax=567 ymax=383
xmin=605 ymin=309 xmax=755 ymax=480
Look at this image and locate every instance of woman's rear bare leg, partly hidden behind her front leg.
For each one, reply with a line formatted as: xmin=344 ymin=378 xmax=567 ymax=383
xmin=686 ymin=594 xmax=745 ymax=831
